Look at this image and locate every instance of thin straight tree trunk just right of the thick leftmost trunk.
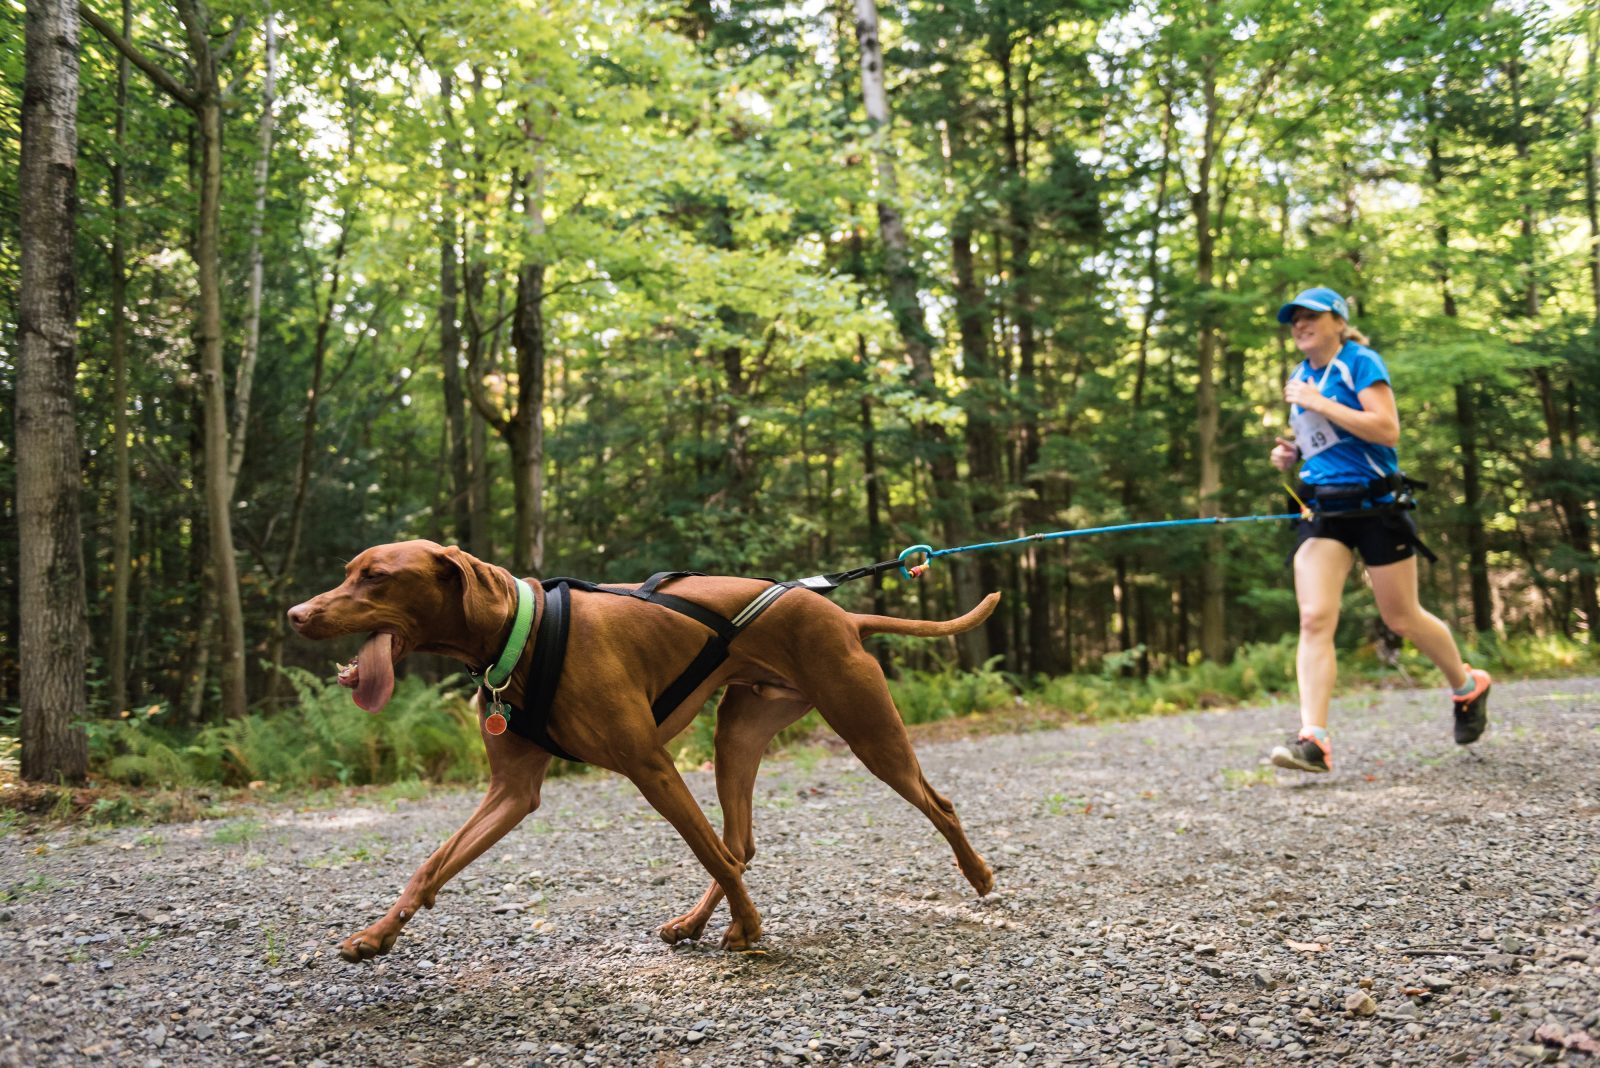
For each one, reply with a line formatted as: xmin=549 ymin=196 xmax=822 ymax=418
xmin=107 ymin=0 xmax=133 ymax=715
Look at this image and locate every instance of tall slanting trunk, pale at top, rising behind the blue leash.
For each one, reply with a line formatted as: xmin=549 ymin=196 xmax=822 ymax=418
xmin=854 ymin=0 xmax=982 ymax=667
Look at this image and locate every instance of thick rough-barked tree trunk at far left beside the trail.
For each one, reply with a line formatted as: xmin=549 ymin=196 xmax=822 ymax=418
xmin=16 ymin=0 xmax=88 ymax=782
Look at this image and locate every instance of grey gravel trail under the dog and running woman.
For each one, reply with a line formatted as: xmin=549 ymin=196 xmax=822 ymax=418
xmin=0 ymin=679 xmax=1600 ymax=1068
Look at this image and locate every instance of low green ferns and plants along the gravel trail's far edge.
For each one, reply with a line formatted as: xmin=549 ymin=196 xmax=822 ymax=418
xmin=0 ymin=636 xmax=1600 ymax=836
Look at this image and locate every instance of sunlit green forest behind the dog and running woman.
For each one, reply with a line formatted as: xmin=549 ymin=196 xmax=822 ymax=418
xmin=0 ymin=0 xmax=1600 ymax=783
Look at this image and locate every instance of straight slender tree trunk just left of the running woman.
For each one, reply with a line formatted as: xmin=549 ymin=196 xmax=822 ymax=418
xmin=1194 ymin=29 xmax=1227 ymax=660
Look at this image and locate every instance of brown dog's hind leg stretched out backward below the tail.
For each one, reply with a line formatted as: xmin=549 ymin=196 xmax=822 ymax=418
xmin=803 ymin=648 xmax=994 ymax=894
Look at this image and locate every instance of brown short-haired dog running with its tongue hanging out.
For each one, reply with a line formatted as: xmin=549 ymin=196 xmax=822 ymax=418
xmin=288 ymin=540 xmax=1000 ymax=961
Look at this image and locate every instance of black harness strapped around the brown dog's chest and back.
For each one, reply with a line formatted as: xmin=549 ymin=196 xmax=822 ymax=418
xmin=478 ymin=571 xmax=806 ymax=763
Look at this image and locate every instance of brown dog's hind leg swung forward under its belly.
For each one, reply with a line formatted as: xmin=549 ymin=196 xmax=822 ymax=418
xmin=658 ymin=684 xmax=811 ymax=943
